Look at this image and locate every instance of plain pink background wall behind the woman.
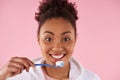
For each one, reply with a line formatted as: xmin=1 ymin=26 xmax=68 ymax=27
xmin=0 ymin=0 xmax=120 ymax=80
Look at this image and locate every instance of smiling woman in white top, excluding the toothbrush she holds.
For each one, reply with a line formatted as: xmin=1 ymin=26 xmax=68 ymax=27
xmin=0 ymin=0 xmax=100 ymax=80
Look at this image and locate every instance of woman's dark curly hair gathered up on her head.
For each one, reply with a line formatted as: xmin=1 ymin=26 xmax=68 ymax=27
xmin=35 ymin=0 xmax=78 ymax=36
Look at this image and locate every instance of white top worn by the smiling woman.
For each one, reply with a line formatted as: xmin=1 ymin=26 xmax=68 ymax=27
xmin=7 ymin=58 xmax=100 ymax=80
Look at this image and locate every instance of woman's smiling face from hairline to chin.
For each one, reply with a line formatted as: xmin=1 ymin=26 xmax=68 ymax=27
xmin=38 ymin=18 xmax=76 ymax=64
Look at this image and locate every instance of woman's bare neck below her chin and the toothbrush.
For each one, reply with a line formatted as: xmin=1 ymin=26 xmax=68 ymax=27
xmin=43 ymin=63 xmax=70 ymax=79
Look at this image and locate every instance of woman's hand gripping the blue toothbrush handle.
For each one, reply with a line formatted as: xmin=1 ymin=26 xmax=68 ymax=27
xmin=0 ymin=57 xmax=34 ymax=80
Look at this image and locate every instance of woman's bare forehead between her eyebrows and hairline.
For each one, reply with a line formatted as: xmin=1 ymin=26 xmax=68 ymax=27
xmin=40 ymin=18 xmax=74 ymax=34
